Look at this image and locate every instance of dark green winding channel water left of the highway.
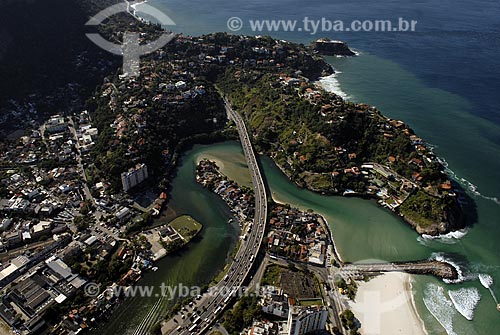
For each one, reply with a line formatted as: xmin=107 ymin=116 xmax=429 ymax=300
xmin=93 ymin=147 xmax=244 ymax=335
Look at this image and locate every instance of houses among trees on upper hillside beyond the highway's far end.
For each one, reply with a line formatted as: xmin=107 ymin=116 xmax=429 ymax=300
xmin=101 ymin=34 xmax=328 ymax=167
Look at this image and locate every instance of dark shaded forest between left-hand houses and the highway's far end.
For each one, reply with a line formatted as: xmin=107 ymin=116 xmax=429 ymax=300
xmin=87 ymin=77 xmax=225 ymax=191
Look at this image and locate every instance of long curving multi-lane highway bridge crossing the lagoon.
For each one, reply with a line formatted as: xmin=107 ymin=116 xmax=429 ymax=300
xmin=162 ymin=99 xmax=268 ymax=335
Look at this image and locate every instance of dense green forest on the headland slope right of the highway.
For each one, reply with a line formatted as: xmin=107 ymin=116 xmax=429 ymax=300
xmin=219 ymin=69 xmax=417 ymax=193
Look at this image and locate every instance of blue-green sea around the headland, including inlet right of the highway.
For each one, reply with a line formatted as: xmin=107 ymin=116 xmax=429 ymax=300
xmin=115 ymin=0 xmax=500 ymax=335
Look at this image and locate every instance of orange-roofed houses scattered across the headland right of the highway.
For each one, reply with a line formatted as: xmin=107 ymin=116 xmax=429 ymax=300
xmin=274 ymin=73 xmax=460 ymax=210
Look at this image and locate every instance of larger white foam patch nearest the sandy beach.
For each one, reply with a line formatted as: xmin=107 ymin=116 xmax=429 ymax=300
xmin=424 ymin=284 xmax=457 ymax=335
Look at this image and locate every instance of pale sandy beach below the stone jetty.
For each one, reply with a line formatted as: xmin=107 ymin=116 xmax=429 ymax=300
xmin=350 ymin=273 xmax=427 ymax=335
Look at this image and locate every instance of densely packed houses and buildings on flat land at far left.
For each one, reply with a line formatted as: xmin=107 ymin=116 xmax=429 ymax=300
xmin=0 ymin=111 xmax=160 ymax=334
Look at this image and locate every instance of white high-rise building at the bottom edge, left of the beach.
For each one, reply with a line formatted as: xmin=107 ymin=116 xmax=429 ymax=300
xmin=288 ymin=306 xmax=328 ymax=335
